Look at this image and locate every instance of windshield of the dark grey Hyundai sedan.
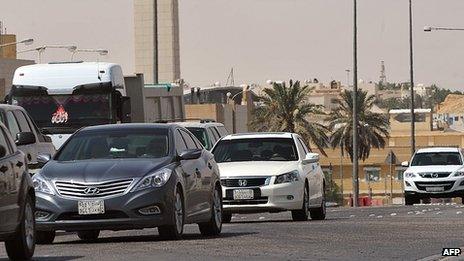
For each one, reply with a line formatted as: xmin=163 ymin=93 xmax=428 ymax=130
xmin=55 ymin=129 xmax=169 ymax=161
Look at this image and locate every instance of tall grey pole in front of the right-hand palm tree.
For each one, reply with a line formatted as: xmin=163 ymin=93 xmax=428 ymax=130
xmin=353 ymin=0 xmax=359 ymax=207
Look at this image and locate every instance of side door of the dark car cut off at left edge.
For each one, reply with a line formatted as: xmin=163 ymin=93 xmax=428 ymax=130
xmin=0 ymin=127 xmax=24 ymax=231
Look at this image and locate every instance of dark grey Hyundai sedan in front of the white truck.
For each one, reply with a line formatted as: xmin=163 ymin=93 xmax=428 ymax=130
xmin=33 ymin=124 xmax=222 ymax=244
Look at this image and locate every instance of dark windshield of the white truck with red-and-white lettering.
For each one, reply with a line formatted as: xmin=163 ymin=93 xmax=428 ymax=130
xmin=12 ymin=94 xmax=112 ymax=133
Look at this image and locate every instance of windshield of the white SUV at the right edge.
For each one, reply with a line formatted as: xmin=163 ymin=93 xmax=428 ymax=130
xmin=411 ymin=152 xmax=462 ymax=166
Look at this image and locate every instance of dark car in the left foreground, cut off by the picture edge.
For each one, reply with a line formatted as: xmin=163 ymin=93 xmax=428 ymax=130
xmin=0 ymin=123 xmax=35 ymax=260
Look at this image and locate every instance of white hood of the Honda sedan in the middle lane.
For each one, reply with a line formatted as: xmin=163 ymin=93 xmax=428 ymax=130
xmin=218 ymin=161 xmax=297 ymax=177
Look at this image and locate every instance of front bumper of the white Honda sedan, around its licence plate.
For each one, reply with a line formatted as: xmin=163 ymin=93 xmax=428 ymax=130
xmin=222 ymin=182 xmax=304 ymax=213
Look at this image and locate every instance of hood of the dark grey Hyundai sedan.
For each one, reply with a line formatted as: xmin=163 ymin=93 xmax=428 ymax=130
xmin=40 ymin=158 xmax=171 ymax=183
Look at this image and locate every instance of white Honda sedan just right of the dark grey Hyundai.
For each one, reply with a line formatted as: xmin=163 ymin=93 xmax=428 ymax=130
xmin=212 ymin=133 xmax=326 ymax=222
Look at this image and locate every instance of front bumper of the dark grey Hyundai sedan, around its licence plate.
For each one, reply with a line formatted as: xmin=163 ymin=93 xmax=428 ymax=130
xmin=36 ymin=184 xmax=174 ymax=231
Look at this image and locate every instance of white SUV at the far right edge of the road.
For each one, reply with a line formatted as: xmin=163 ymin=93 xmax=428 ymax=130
xmin=402 ymin=148 xmax=464 ymax=205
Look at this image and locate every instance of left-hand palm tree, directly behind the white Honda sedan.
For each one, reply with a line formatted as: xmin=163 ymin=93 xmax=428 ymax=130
xmin=251 ymin=80 xmax=329 ymax=156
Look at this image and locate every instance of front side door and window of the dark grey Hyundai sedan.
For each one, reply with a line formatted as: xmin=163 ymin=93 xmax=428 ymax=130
xmin=179 ymin=129 xmax=209 ymax=215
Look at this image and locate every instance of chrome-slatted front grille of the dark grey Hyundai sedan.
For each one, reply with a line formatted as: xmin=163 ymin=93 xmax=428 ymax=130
xmin=55 ymin=179 xmax=133 ymax=198
